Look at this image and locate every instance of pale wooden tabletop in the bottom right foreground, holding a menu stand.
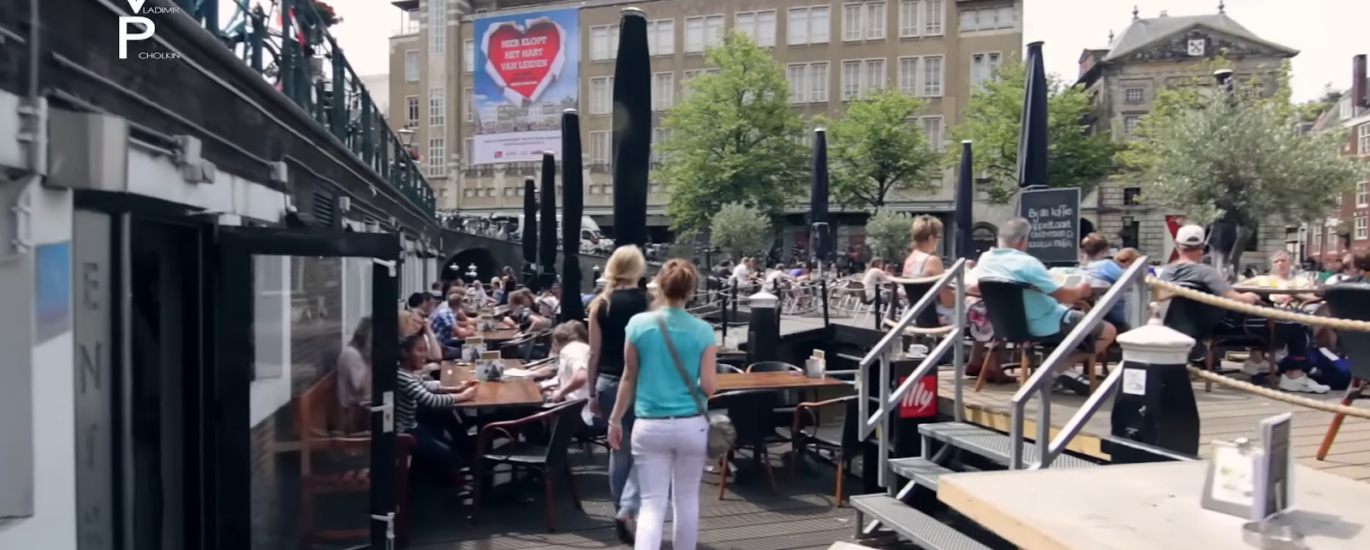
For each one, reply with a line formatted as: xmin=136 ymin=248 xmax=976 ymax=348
xmin=937 ymin=462 xmax=1370 ymax=550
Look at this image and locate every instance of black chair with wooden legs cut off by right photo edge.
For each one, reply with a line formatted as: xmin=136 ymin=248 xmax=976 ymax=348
xmin=1317 ymin=283 xmax=1370 ymax=461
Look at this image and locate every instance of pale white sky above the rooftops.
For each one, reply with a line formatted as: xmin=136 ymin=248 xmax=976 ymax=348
xmin=222 ymin=0 xmax=1370 ymax=101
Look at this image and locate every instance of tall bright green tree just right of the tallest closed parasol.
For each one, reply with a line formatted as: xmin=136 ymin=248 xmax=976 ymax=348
xmin=655 ymin=33 xmax=808 ymax=230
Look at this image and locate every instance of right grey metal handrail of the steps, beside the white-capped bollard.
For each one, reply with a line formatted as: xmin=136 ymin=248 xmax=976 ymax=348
xmin=1008 ymin=256 xmax=1151 ymax=469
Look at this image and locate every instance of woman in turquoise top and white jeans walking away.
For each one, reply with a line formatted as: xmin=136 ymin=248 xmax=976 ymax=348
xmin=608 ymin=259 xmax=718 ymax=550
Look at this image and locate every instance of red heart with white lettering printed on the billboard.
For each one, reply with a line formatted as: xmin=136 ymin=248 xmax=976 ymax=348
xmin=486 ymin=21 xmax=562 ymax=101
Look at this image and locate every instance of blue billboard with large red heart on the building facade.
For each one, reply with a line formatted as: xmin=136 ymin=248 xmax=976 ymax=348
xmin=466 ymin=8 xmax=581 ymax=165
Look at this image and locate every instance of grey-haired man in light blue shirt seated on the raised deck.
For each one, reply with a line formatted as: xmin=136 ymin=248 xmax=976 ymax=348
xmin=966 ymin=218 xmax=1118 ymax=395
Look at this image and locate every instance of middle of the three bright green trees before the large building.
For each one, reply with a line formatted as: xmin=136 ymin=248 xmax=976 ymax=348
xmin=815 ymin=89 xmax=941 ymax=211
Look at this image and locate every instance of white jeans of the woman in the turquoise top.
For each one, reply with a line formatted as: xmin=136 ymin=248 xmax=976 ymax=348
xmin=632 ymin=416 xmax=708 ymax=550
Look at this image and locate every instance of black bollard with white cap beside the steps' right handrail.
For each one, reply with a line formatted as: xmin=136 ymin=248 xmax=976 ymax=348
xmin=1110 ymin=322 xmax=1199 ymax=464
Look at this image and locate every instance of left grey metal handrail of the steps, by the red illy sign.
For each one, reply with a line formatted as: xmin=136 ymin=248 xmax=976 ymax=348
xmin=856 ymin=258 xmax=966 ymax=491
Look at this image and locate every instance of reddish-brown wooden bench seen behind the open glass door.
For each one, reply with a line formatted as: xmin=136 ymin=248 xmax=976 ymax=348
xmin=296 ymin=372 xmax=414 ymax=546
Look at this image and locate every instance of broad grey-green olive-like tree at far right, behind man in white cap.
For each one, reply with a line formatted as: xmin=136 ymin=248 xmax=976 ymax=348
xmin=1118 ymin=64 xmax=1365 ymax=263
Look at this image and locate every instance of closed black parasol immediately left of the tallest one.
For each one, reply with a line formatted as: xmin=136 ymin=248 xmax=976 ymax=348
xmin=560 ymin=108 xmax=585 ymax=321
